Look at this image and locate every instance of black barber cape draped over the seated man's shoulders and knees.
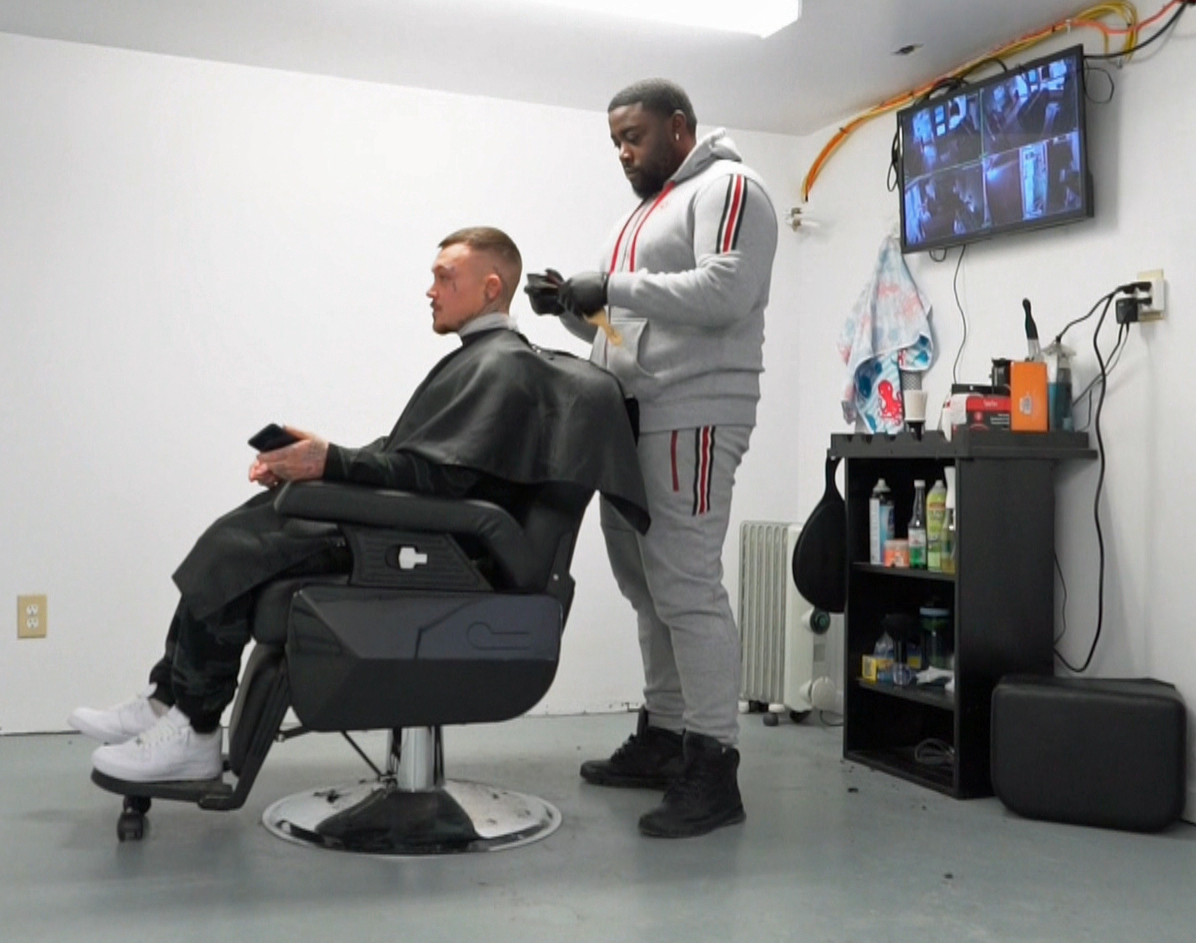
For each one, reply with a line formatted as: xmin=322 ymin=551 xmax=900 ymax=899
xmin=175 ymin=329 xmax=648 ymax=619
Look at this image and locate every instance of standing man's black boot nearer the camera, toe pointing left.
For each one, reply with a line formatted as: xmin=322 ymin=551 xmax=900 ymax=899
xmin=640 ymin=732 xmax=746 ymax=838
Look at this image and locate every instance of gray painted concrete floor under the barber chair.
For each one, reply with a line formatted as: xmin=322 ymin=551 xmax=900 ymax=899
xmin=0 ymin=714 xmax=1196 ymax=943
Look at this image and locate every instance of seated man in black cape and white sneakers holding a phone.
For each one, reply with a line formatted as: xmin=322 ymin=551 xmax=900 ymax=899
xmin=69 ymin=227 xmax=647 ymax=783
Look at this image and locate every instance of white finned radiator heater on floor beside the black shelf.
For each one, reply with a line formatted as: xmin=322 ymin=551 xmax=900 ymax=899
xmin=739 ymin=521 xmax=837 ymax=712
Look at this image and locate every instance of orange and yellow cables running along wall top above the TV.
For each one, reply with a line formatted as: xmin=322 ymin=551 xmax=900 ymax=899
xmin=801 ymin=0 xmax=1183 ymax=202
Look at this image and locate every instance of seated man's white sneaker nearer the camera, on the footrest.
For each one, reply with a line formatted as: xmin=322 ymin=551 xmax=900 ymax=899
xmin=91 ymin=707 xmax=224 ymax=783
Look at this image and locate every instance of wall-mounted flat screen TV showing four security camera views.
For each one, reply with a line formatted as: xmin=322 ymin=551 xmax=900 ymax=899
xmin=897 ymin=45 xmax=1093 ymax=253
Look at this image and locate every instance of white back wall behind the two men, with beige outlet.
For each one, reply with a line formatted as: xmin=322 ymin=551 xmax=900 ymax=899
xmin=0 ymin=35 xmax=808 ymax=732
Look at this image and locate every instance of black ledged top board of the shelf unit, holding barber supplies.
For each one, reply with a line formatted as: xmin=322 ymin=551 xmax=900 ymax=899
xmin=828 ymin=428 xmax=1097 ymax=461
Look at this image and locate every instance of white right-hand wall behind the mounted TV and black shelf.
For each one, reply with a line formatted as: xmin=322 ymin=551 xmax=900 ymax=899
xmin=797 ymin=33 xmax=1196 ymax=817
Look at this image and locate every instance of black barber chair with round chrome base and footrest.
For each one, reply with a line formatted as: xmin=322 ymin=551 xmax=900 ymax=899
xmin=92 ymin=482 xmax=592 ymax=856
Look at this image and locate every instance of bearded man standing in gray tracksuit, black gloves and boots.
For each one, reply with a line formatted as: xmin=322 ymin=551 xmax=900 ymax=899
xmin=529 ymin=79 xmax=776 ymax=838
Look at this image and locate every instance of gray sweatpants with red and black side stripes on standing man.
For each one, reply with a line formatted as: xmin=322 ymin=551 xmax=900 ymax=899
xmin=602 ymin=426 xmax=751 ymax=746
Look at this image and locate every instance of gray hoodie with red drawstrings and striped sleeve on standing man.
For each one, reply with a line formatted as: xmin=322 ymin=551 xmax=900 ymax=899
xmin=562 ymin=129 xmax=776 ymax=432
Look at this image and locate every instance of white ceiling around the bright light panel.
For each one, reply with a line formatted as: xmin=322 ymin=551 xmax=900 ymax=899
xmin=0 ymin=0 xmax=1085 ymax=134
